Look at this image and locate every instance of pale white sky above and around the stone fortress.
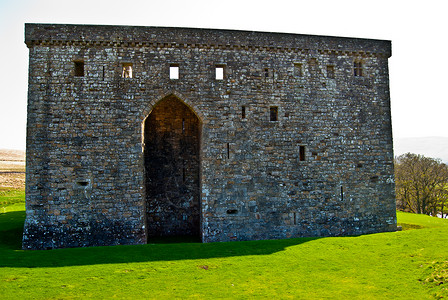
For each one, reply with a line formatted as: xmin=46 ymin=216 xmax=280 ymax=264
xmin=0 ymin=0 xmax=448 ymax=150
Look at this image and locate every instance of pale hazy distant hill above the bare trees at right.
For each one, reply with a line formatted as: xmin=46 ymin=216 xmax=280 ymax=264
xmin=394 ymin=137 xmax=448 ymax=163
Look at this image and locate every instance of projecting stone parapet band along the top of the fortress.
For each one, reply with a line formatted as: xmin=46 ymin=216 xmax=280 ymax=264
xmin=25 ymin=23 xmax=391 ymax=57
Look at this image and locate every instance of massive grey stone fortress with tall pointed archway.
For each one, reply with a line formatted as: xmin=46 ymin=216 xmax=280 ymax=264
xmin=23 ymin=24 xmax=396 ymax=249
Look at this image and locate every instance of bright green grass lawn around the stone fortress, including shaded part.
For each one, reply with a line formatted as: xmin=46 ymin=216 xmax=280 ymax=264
xmin=0 ymin=194 xmax=448 ymax=299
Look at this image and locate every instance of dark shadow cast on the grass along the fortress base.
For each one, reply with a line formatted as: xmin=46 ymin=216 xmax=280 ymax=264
xmin=0 ymin=212 xmax=318 ymax=268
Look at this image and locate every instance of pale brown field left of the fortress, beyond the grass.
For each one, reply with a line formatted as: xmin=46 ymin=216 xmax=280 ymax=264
xmin=0 ymin=149 xmax=25 ymax=190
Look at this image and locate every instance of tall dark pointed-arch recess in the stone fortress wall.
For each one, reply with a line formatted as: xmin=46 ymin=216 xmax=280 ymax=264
xmin=144 ymin=95 xmax=201 ymax=239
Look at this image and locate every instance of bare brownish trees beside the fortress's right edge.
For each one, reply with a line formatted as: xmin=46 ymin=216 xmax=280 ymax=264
xmin=395 ymin=153 xmax=448 ymax=217
